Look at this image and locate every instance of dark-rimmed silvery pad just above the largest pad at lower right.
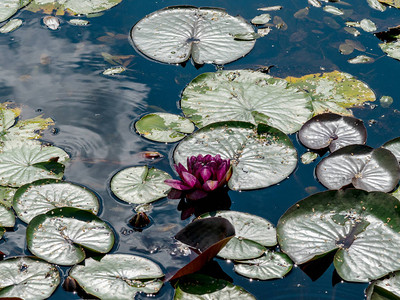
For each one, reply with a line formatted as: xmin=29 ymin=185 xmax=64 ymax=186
xmin=315 ymin=145 xmax=400 ymax=192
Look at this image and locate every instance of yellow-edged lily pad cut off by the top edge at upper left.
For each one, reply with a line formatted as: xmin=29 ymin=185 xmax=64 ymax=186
xmin=27 ymin=0 xmax=122 ymax=15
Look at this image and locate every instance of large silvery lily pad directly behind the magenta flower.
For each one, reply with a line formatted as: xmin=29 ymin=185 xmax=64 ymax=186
xmin=174 ymin=122 xmax=297 ymax=190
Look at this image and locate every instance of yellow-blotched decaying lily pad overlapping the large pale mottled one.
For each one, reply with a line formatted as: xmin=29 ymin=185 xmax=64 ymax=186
xmin=286 ymin=71 xmax=375 ymax=115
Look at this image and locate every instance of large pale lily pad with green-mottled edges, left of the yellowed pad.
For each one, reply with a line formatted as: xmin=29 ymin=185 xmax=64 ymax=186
xmin=181 ymin=70 xmax=313 ymax=133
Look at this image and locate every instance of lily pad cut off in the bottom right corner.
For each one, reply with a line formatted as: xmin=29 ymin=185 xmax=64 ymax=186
xmin=366 ymin=271 xmax=400 ymax=300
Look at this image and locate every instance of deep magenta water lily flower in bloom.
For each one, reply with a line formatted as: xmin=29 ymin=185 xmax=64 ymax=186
xmin=165 ymin=154 xmax=232 ymax=200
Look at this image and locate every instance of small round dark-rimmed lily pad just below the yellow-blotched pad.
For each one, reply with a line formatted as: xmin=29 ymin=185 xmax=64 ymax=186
xmin=299 ymin=113 xmax=367 ymax=152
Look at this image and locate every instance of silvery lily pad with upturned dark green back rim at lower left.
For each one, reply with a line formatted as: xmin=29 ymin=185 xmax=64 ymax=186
xmin=26 ymin=207 xmax=114 ymax=266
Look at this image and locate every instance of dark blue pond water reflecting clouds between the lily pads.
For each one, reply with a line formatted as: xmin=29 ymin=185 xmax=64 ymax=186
xmin=0 ymin=0 xmax=400 ymax=300
